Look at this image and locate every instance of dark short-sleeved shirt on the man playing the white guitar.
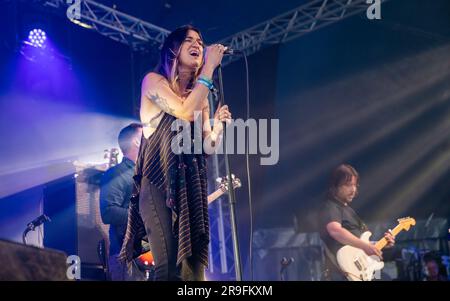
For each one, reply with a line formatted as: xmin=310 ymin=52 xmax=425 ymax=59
xmin=319 ymin=198 xmax=368 ymax=270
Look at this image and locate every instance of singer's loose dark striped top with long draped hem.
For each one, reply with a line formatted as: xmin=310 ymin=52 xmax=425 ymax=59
xmin=119 ymin=113 xmax=209 ymax=266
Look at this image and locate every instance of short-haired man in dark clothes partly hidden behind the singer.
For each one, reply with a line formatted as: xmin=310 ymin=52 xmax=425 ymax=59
xmin=100 ymin=123 xmax=142 ymax=281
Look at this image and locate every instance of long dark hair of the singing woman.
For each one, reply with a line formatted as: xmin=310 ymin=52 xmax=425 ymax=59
xmin=155 ymin=25 xmax=203 ymax=94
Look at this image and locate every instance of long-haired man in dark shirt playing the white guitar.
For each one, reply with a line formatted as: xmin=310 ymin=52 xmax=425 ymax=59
xmin=319 ymin=164 xmax=395 ymax=281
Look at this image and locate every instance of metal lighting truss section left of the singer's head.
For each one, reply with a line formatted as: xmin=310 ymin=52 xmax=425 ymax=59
xmin=41 ymin=0 xmax=170 ymax=50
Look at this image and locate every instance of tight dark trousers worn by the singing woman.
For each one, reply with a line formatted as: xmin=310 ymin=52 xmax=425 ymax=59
xmin=139 ymin=178 xmax=204 ymax=281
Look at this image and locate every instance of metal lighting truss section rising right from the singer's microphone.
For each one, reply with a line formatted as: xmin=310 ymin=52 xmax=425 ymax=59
xmin=219 ymin=0 xmax=388 ymax=65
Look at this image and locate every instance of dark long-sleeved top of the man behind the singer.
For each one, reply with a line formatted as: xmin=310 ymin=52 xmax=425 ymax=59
xmin=100 ymin=157 xmax=135 ymax=255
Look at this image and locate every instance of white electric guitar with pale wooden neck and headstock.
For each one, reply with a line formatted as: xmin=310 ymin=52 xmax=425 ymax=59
xmin=336 ymin=217 xmax=416 ymax=281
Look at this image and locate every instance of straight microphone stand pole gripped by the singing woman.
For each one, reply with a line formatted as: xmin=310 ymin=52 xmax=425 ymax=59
xmin=217 ymin=65 xmax=242 ymax=281
